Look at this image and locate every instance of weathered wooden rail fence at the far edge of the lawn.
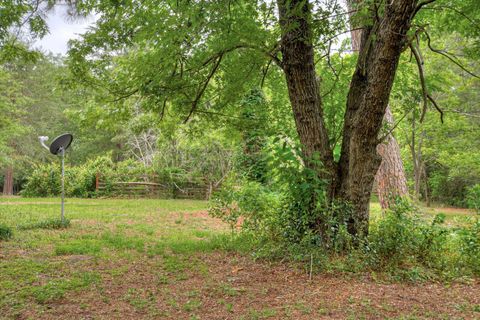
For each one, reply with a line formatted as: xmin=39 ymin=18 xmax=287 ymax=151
xmin=95 ymin=173 xmax=212 ymax=199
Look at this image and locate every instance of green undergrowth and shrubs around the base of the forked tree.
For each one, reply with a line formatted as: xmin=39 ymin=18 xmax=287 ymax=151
xmin=209 ymin=142 xmax=480 ymax=281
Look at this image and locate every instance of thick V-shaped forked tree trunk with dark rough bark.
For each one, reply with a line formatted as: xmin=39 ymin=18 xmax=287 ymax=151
xmin=278 ymin=0 xmax=417 ymax=237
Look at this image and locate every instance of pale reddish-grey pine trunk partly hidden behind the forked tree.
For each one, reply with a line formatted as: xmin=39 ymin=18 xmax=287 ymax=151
xmin=347 ymin=0 xmax=408 ymax=209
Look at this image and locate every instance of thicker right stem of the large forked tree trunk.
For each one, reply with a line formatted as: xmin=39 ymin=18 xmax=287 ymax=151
xmin=336 ymin=0 xmax=417 ymax=236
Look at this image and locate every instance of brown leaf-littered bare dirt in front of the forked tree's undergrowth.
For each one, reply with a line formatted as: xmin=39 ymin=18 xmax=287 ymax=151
xmin=21 ymin=253 xmax=480 ymax=319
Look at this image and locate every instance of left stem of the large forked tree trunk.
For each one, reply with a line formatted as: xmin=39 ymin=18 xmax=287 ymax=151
xmin=277 ymin=0 xmax=334 ymax=178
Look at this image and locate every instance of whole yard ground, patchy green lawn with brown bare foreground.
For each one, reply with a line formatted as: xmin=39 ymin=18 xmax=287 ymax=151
xmin=0 ymin=198 xmax=480 ymax=319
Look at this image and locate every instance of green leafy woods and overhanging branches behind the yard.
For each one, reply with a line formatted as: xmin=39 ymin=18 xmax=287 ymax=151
xmin=0 ymin=1 xmax=480 ymax=206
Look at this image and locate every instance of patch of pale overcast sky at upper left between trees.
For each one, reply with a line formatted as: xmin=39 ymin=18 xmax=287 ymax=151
xmin=34 ymin=6 xmax=95 ymax=55
